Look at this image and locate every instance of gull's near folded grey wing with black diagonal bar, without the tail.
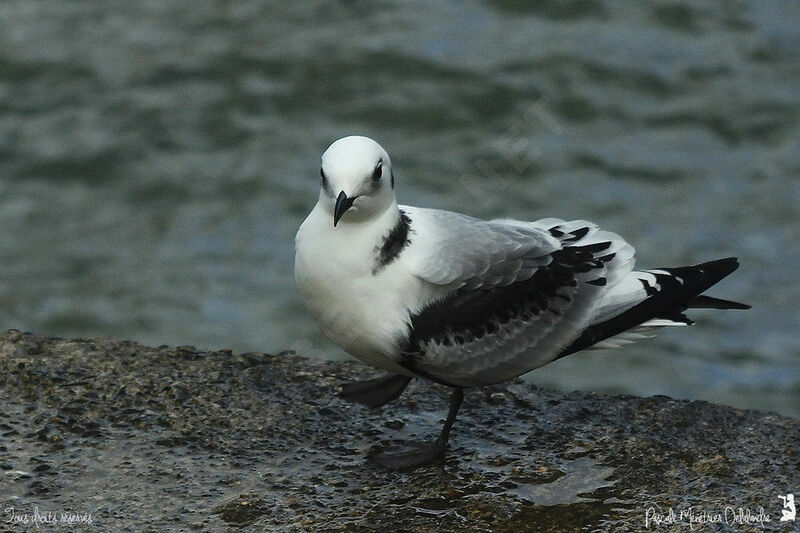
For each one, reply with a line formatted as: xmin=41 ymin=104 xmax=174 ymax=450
xmin=402 ymin=211 xmax=633 ymax=386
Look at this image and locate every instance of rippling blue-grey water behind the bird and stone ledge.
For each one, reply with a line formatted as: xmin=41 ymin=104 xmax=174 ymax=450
xmin=0 ymin=0 xmax=800 ymax=416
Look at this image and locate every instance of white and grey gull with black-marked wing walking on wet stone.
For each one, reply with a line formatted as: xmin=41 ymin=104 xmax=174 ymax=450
xmin=295 ymin=136 xmax=749 ymax=469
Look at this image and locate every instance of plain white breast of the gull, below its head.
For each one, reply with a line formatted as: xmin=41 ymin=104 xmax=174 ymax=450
xmin=295 ymin=202 xmax=424 ymax=374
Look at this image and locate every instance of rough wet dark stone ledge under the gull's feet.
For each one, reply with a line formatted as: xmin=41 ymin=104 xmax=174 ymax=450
xmin=0 ymin=330 xmax=800 ymax=532
